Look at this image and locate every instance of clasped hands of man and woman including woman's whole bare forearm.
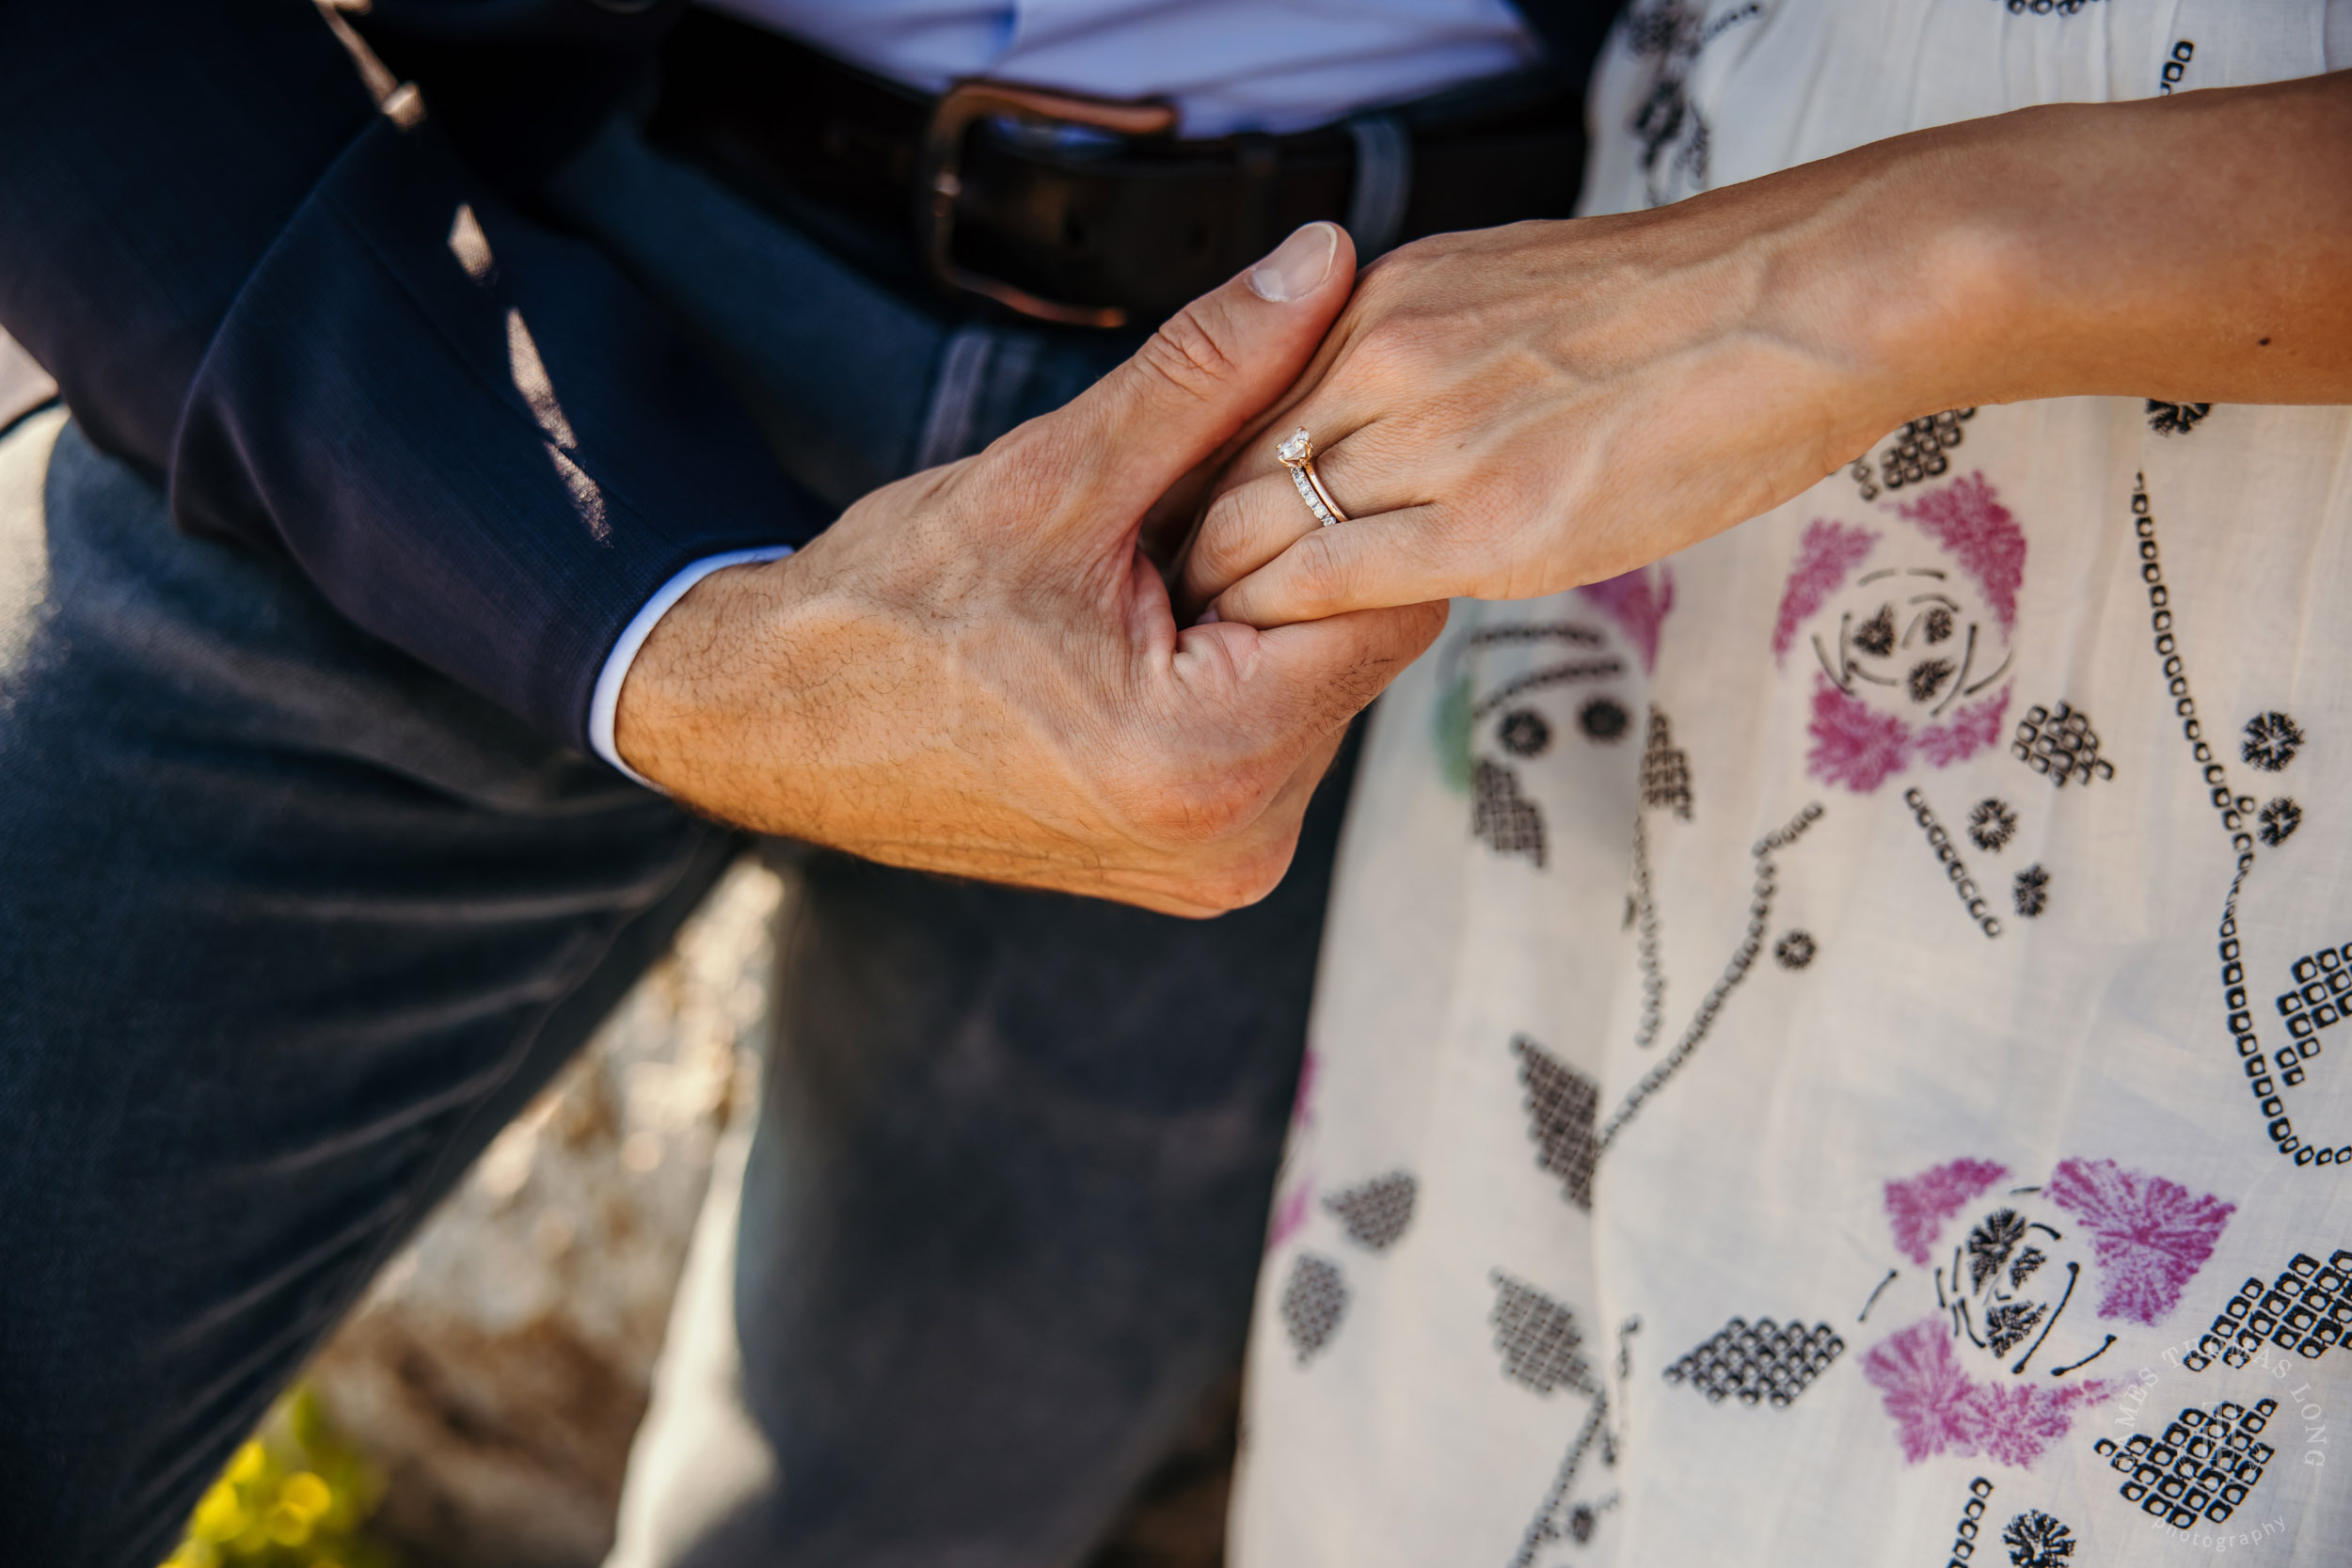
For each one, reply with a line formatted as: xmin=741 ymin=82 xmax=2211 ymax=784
xmin=616 ymin=72 xmax=2352 ymax=914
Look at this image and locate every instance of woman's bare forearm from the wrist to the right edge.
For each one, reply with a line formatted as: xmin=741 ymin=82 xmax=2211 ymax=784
xmin=1825 ymin=72 xmax=2352 ymax=414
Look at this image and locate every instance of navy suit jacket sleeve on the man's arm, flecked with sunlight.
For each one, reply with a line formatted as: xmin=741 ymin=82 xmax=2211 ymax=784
xmin=0 ymin=0 xmax=826 ymax=761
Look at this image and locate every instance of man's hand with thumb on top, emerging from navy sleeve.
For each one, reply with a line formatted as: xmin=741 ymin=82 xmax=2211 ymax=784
xmin=616 ymin=223 xmax=1444 ymax=914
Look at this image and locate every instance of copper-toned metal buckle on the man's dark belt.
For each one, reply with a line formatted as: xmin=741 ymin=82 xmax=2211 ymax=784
xmin=915 ymin=77 xmax=1176 ymax=326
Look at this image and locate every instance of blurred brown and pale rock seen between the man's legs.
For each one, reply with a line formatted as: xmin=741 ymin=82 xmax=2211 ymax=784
xmin=310 ymin=861 xmax=784 ymax=1568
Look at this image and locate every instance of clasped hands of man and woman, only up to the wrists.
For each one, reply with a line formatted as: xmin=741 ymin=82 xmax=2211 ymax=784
xmin=616 ymin=186 xmax=1910 ymax=914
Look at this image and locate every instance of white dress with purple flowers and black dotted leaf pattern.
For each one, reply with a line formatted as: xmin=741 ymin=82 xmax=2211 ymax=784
xmin=1232 ymin=0 xmax=2352 ymax=1568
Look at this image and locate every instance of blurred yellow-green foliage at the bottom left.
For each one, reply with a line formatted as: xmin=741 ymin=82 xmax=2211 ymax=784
xmin=163 ymin=1387 xmax=395 ymax=1568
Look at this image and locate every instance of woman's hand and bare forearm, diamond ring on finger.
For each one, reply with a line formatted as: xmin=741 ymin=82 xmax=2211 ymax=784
xmin=1184 ymin=72 xmax=2352 ymax=626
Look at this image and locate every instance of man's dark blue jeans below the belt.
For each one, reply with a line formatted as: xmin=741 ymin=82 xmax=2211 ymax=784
xmin=0 ymin=132 xmax=1336 ymax=1568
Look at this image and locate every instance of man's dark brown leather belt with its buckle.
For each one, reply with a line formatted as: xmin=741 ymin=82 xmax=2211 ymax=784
xmin=649 ymin=9 xmax=1585 ymax=326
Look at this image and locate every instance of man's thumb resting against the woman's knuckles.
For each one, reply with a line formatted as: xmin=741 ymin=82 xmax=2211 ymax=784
xmin=1052 ymin=223 xmax=1355 ymax=522
